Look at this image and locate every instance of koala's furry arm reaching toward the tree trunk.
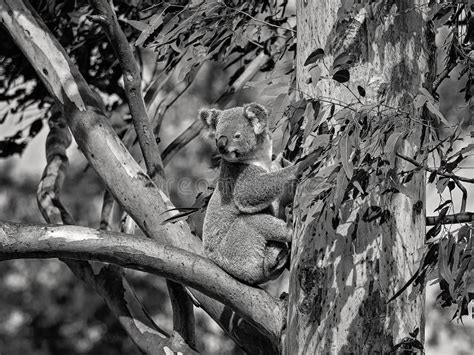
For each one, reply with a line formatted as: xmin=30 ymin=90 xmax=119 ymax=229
xmin=234 ymin=165 xmax=298 ymax=213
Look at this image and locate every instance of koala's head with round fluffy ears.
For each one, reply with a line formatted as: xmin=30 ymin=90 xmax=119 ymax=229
xmin=199 ymin=103 xmax=268 ymax=162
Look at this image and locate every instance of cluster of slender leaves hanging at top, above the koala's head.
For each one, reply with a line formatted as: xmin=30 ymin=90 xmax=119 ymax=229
xmin=136 ymin=0 xmax=293 ymax=82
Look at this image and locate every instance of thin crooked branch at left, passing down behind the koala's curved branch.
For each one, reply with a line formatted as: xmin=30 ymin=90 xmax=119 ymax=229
xmin=37 ymin=107 xmax=183 ymax=354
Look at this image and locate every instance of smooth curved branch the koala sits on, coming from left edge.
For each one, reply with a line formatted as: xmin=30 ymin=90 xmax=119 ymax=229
xmin=0 ymin=222 xmax=283 ymax=336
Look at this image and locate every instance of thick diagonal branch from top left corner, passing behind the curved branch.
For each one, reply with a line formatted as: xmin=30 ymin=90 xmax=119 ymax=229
xmin=0 ymin=0 xmax=284 ymax=354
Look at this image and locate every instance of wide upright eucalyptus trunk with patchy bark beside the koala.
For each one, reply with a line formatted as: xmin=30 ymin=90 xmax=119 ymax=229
xmin=285 ymin=0 xmax=434 ymax=355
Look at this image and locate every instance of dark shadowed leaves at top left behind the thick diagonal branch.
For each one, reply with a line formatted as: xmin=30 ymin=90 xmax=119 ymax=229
xmin=0 ymin=0 xmax=151 ymax=157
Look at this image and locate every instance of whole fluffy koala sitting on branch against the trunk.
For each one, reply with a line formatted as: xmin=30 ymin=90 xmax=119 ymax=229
xmin=199 ymin=103 xmax=298 ymax=284
